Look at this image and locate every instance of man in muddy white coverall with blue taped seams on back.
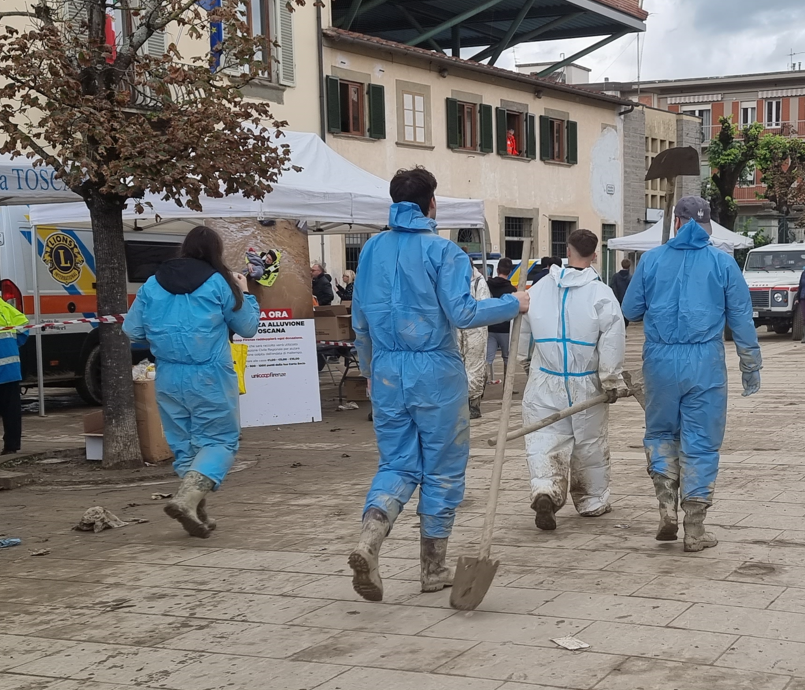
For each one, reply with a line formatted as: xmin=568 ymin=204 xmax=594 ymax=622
xmin=518 ymin=230 xmax=626 ymax=530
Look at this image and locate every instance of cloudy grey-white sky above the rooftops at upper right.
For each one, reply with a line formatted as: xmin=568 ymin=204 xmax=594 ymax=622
xmin=497 ymin=0 xmax=805 ymax=81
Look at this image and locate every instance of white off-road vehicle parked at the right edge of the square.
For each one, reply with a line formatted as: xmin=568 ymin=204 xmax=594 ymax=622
xmin=744 ymin=243 xmax=805 ymax=340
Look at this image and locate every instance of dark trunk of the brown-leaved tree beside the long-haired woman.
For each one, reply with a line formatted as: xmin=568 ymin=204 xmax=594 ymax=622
xmin=87 ymin=194 xmax=142 ymax=469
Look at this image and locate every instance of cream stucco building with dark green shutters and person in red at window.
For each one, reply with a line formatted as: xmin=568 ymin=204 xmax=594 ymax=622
xmin=4 ymin=0 xmax=646 ymax=277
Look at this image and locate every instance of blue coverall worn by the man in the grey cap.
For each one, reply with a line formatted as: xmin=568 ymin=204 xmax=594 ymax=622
xmin=622 ymin=220 xmax=762 ymax=505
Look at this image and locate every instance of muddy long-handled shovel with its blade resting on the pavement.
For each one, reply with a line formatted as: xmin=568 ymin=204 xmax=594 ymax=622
xmin=450 ymin=238 xmax=531 ymax=611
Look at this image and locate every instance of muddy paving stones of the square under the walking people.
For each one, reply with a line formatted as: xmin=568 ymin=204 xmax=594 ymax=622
xmin=0 ymin=326 xmax=805 ymax=690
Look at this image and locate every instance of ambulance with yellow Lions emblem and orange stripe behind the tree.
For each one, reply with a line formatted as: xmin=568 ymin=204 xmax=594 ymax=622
xmin=0 ymin=206 xmax=184 ymax=405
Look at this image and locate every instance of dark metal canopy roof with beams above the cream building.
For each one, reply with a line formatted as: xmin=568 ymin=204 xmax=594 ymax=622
xmin=332 ymin=0 xmax=646 ymax=63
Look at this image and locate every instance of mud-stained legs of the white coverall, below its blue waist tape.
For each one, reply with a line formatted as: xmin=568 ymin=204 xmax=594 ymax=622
xmin=523 ymin=372 xmax=610 ymax=515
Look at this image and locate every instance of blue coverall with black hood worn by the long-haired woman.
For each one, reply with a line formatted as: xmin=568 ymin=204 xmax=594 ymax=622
xmin=123 ymin=259 xmax=260 ymax=489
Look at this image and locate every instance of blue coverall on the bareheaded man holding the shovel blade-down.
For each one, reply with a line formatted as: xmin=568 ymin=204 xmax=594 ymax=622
xmin=352 ymin=202 xmax=519 ymax=539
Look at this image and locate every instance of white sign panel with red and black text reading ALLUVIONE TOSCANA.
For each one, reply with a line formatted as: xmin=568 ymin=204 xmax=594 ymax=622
xmin=235 ymin=309 xmax=321 ymax=427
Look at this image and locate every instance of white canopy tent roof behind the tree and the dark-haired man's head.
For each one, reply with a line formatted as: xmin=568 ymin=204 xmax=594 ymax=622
xmin=26 ymin=132 xmax=484 ymax=232
